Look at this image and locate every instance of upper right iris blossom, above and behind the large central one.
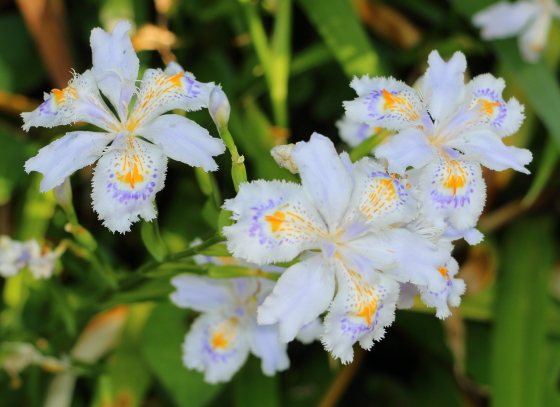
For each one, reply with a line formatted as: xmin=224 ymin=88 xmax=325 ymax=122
xmin=345 ymin=51 xmax=532 ymax=234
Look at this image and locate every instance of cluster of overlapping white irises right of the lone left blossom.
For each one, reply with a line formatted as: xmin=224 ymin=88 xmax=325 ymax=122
xmin=223 ymin=51 xmax=532 ymax=363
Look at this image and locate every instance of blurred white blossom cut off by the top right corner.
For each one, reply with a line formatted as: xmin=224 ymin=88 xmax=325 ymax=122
xmin=472 ymin=0 xmax=560 ymax=63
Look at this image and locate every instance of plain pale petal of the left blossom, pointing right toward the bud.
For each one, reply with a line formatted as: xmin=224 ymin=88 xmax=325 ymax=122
xmin=136 ymin=114 xmax=226 ymax=171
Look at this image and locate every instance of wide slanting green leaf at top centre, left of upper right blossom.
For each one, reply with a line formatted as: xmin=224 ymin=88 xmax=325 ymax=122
xmin=298 ymin=0 xmax=383 ymax=77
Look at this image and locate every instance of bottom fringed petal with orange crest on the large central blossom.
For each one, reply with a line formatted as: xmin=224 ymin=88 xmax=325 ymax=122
xmin=322 ymin=265 xmax=399 ymax=363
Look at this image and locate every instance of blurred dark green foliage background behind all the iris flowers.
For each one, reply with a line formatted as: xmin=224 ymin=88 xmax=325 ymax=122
xmin=0 ymin=0 xmax=560 ymax=407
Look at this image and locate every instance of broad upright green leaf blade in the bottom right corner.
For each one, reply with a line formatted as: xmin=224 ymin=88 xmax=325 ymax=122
xmin=490 ymin=218 xmax=554 ymax=407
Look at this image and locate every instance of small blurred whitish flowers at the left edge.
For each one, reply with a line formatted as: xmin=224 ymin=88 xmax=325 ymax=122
xmin=0 ymin=236 xmax=64 ymax=279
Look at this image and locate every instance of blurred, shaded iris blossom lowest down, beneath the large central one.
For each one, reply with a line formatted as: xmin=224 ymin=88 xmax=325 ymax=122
xmin=170 ymin=256 xmax=321 ymax=383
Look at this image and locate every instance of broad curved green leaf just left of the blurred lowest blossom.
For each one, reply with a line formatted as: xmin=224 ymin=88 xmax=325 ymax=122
xmin=142 ymin=303 xmax=221 ymax=407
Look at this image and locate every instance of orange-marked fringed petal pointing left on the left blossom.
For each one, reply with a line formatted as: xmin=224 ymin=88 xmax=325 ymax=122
xmin=21 ymin=71 xmax=118 ymax=132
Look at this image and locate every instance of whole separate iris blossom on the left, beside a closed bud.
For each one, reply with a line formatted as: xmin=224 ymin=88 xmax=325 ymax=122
xmin=22 ymin=21 xmax=225 ymax=233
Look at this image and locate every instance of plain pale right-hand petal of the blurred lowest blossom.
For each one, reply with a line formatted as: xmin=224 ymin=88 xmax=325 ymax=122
xmin=249 ymin=321 xmax=290 ymax=376
